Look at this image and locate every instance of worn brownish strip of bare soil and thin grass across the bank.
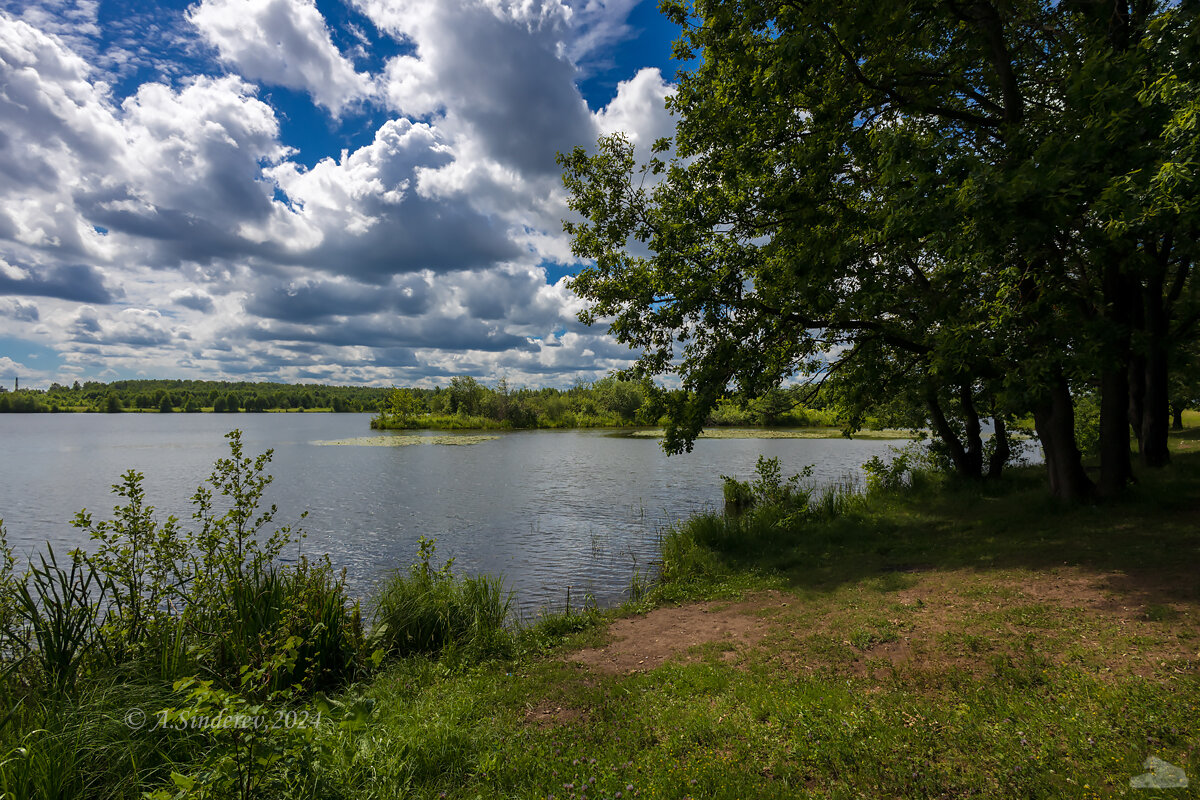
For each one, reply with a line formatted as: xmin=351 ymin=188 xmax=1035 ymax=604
xmin=568 ymin=567 xmax=1200 ymax=680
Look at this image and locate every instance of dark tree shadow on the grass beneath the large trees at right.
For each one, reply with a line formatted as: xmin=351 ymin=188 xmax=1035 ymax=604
xmin=676 ymin=443 xmax=1200 ymax=603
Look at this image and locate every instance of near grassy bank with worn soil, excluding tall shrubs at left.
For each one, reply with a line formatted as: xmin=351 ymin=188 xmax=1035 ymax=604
xmin=0 ymin=438 xmax=1200 ymax=798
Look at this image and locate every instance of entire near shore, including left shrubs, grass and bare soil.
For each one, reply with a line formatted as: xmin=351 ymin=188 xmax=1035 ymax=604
xmin=0 ymin=428 xmax=1200 ymax=800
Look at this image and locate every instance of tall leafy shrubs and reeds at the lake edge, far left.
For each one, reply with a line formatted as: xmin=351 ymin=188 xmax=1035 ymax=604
xmin=0 ymin=431 xmax=364 ymax=693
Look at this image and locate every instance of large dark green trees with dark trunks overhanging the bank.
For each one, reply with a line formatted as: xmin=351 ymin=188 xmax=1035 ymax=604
xmin=560 ymin=0 xmax=1200 ymax=499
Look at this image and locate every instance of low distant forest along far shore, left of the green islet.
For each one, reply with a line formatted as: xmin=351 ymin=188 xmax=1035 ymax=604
xmin=0 ymin=380 xmax=389 ymax=414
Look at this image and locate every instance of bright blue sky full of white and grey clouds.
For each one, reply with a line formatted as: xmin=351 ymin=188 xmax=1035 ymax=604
xmin=0 ymin=0 xmax=679 ymax=386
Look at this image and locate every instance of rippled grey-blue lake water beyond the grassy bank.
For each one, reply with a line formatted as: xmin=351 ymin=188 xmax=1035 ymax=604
xmin=0 ymin=414 xmax=905 ymax=613
